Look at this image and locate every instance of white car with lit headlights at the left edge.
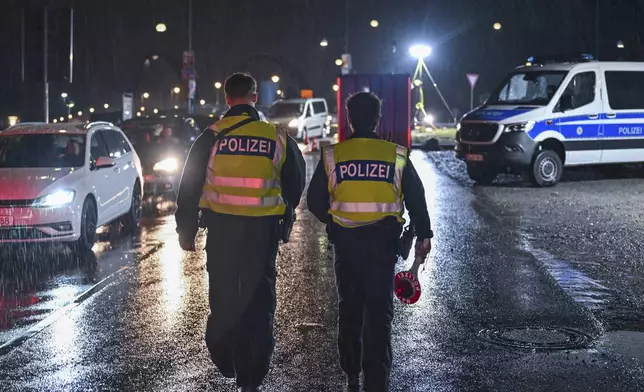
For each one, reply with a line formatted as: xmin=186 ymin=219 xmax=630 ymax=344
xmin=0 ymin=122 xmax=143 ymax=252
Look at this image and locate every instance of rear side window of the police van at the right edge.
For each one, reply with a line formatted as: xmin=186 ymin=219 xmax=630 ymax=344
xmin=605 ymin=71 xmax=644 ymax=110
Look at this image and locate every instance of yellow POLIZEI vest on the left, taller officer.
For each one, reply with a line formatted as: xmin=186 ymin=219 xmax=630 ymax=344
xmin=199 ymin=116 xmax=286 ymax=216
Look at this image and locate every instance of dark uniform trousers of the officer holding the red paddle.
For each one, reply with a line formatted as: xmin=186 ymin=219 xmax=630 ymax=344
xmin=330 ymin=218 xmax=402 ymax=392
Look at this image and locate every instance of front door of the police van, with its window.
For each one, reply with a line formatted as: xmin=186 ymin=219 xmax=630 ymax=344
xmin=555 ymin=70 xmax=603 ymax=166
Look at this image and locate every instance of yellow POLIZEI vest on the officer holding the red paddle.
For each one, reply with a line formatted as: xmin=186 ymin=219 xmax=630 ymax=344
xmin=322 ymin=138 xmax=409 ymax=227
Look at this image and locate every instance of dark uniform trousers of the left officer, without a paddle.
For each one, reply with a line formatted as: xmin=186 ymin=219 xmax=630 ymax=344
xmin=206 ymin=212 xmax=279 ymax=386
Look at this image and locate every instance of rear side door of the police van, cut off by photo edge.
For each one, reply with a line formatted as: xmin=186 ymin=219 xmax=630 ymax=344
xmin=602 ymin=67 xmax=644 ymax=163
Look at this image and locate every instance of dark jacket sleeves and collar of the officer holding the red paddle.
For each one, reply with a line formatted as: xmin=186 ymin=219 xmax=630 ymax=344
xmin=307 ymin=132 xmax=431 ymax=239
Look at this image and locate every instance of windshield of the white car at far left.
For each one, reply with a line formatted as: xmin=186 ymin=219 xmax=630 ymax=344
xmin=0 ymin=134 xmax=85 ymax=168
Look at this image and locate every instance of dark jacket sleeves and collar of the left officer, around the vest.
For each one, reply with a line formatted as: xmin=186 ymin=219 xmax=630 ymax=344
xmin=175 ymin=105 xmax=306 ymax=240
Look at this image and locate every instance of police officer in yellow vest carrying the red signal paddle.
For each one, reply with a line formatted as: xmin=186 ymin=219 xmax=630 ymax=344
xmin=307 ymin=93 xmax=433 ymax=392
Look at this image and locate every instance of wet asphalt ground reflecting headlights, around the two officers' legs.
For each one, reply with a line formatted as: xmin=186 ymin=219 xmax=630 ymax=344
xmin=0 ymin=152 xmax=644 ymax=391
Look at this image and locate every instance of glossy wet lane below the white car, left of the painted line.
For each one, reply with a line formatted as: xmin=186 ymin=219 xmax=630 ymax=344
xmin=0 ymin=224 xmax=164 ymax=346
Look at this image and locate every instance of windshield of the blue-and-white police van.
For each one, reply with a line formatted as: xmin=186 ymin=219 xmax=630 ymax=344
xmin=487 ymin=71 xmax=568 ymax=106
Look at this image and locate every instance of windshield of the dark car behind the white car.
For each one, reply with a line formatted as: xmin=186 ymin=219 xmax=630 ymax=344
xmin=121 ymin=121 xmax=195 ymax=146
